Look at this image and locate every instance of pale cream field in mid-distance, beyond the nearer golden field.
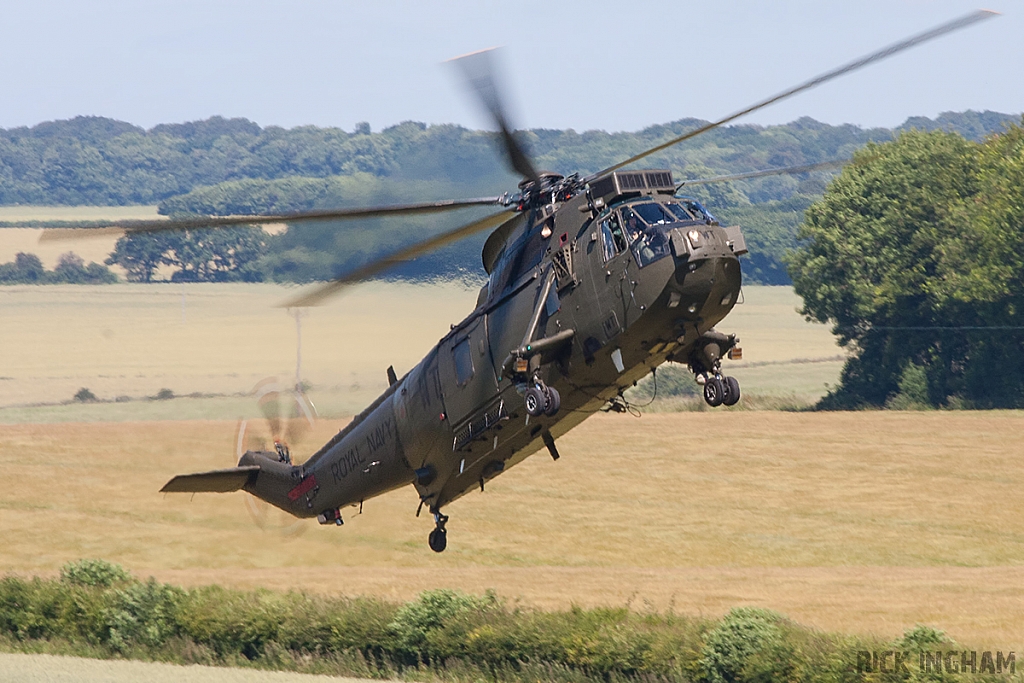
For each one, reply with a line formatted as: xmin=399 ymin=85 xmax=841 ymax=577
xmin=0 ymin=282 xmax=842 ymax=422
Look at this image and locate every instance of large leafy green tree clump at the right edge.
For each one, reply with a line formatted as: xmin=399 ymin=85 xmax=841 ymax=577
xmin=791 ymin=126 xmax=1024 ymax=408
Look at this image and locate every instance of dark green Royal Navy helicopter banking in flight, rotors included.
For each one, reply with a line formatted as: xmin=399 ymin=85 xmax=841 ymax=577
xmin=59 ymin=11 xmax=994 ymax=552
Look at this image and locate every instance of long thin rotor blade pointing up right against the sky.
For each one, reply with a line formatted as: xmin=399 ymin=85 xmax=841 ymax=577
xmin=585 ymin=9 xmax=998 ymax=181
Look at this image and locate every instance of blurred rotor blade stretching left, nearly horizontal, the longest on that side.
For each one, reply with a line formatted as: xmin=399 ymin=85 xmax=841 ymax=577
xmin=39 ymin=197 xmax=502 ymax=242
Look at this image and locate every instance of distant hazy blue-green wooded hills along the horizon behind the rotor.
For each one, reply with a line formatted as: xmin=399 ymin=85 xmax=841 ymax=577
xmin=0 ymin=112 xmax=1009 ymax=284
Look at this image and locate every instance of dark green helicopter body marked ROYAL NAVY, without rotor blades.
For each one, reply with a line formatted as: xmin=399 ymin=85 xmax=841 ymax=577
xmin=240 ymin=167 xmax=745 ymax=523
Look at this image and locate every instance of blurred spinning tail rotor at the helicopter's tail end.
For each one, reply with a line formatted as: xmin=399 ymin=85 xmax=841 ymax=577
xmin=231 ymin=377 xmax=316 ymax=537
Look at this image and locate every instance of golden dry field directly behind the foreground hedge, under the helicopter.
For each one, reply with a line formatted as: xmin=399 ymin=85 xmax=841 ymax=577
xmin=0 ymin=412 xmax=1024 ymax=650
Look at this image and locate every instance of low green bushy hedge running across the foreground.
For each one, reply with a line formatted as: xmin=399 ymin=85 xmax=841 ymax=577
xmin=0 ymin=560 xmax=1009 ymax=683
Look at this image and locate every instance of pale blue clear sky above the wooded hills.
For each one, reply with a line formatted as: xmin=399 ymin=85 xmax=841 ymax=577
xmin=0 ymin=0 xmax=1024 ymax=131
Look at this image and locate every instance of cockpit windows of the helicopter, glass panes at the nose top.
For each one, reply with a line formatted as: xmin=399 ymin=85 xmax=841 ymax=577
xmin=598 ymin=198 xmax=715 ymax=268
